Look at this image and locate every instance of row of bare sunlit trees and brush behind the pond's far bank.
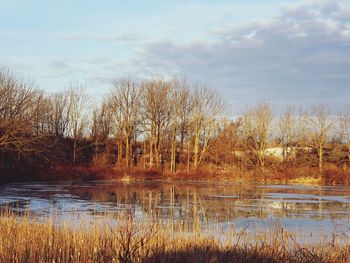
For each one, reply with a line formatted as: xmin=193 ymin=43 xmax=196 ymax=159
xmin=0 ymin=70 xmax=350 ymax=179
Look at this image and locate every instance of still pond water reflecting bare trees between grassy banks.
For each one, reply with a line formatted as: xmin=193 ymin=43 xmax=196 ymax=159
xmin=0 ymin=181 xmax=350 ymax=239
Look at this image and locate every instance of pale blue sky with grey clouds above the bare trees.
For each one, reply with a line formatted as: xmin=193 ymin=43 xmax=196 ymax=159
xmin=0 ymin=0 xmax=350 ymax=111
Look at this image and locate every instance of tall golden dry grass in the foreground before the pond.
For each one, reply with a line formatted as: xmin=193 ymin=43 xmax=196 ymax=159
xmin=0 ymin=211 xmax=350 ymax=263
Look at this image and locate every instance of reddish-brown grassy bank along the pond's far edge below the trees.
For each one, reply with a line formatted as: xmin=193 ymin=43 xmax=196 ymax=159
xmin=0 ymin=166 xmax=350 ymax=185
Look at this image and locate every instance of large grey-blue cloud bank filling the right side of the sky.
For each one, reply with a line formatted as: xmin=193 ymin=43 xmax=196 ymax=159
xmin=129 ymin=0 xmax=350 ymax=112
